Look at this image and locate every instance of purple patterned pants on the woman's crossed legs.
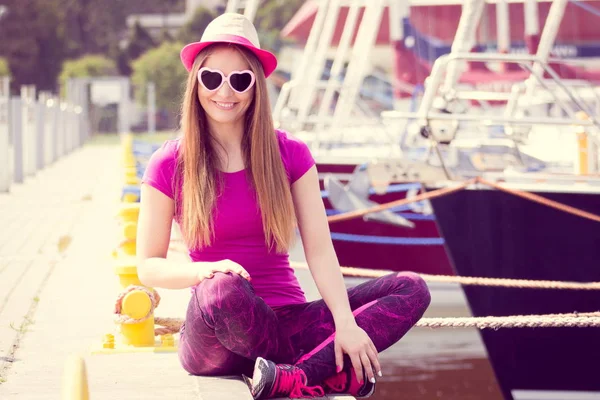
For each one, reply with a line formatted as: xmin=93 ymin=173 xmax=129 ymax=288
xmin=179 ymin=272 xmax=430 ymax=385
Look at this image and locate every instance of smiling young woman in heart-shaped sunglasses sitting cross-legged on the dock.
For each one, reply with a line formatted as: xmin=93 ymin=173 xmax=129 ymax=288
xmin=137 ymin=13 xmax=430 ymax=399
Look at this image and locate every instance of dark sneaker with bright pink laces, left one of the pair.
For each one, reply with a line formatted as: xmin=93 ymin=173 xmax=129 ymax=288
xmin=249 ymin=357 xmax=324 ymax=399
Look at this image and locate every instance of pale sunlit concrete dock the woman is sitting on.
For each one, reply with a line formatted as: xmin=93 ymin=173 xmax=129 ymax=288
xmin=0 ymin=145 xmax=356 ymax=400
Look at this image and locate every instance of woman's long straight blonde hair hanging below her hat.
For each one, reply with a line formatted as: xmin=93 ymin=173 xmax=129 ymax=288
xmin=175 ymin=45 xmax=296 ymax=253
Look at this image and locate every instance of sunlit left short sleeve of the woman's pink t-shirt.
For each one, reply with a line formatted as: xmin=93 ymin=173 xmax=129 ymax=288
xmin=142 ymin=140 xmax=177 ymax=199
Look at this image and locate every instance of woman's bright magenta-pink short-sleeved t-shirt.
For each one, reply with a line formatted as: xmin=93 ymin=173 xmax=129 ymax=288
xmin=142 ymin=130 xmax=315 ymax=307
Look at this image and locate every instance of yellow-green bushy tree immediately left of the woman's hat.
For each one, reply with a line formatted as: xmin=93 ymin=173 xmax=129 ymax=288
xmin=131 ymin=42 xmax=188 ymax=116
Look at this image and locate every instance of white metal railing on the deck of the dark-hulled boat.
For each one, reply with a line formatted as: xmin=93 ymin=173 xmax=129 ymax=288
xmin=381 ymin=53 xmax=600 ymax=142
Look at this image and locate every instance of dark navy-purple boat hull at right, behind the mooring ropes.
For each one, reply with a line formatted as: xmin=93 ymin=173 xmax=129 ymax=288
xmin=431 ymin=189 xmax=600 ymax=399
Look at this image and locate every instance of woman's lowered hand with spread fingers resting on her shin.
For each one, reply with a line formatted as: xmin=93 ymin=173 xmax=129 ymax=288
xmin=335 ymin=321 xmax=381 ymax=383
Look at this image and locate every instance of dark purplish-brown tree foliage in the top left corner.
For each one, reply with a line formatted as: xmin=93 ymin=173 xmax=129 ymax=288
xmin=0 ymin=0 xmax=131 ymax=91
